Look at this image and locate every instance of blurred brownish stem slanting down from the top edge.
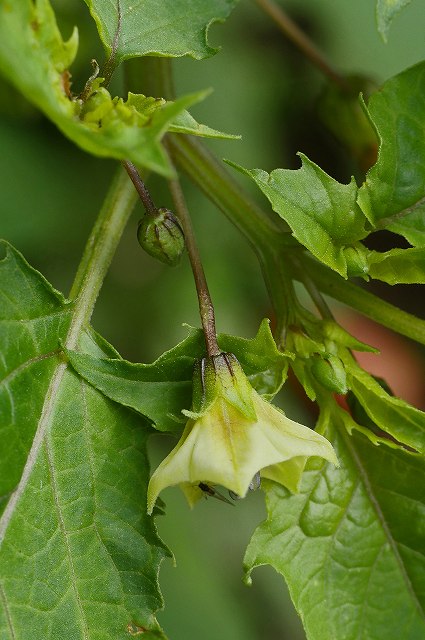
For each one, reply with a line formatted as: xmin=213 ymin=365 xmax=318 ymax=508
xmin=256 ymin=0 xmax=346 ymax=89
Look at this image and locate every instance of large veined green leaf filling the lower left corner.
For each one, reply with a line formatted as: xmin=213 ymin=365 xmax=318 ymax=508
xmin=0 ymin=242 xmax=168 ymax=640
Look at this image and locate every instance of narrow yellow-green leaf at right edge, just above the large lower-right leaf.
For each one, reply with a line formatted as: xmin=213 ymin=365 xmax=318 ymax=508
xmin=345 ymin=359 xmax=425 ymax=454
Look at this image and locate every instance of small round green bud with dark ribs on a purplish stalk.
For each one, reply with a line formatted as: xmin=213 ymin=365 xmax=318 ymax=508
xmin=137 ymin=207 xmax=185 ymax=266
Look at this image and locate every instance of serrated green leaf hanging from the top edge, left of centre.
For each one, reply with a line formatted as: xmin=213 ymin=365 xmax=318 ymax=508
xmin=85 ymin=0 xmax=237 ymax=66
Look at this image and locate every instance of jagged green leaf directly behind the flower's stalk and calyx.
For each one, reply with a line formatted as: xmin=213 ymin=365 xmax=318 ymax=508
xmin=67 ymin=320 xmax=288 ymax=432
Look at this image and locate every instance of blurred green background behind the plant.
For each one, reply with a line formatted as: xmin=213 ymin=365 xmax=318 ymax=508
xmin=0 ymin=0 xmax=425 ymax=640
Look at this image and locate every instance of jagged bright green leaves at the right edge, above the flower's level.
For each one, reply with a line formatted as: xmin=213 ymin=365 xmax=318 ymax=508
xmin=230 ymin=62 xmax=425 ymax=284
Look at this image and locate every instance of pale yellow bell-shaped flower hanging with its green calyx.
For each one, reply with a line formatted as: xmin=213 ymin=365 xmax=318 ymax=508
xmin=148 ymin=353 xmax=338 ymax=513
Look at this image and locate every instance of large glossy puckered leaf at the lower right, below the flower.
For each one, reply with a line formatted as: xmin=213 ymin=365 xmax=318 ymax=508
xmin=245 ymin=404 xmax=425 ymax=640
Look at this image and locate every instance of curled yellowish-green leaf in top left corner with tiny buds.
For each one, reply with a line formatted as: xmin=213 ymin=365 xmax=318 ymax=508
xmin=0 ymin=0 xmax=234 ymax=176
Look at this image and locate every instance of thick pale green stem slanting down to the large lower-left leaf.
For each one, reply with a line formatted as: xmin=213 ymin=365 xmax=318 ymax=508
xmin=65 ymin=168 xmax=137 ymax=349
